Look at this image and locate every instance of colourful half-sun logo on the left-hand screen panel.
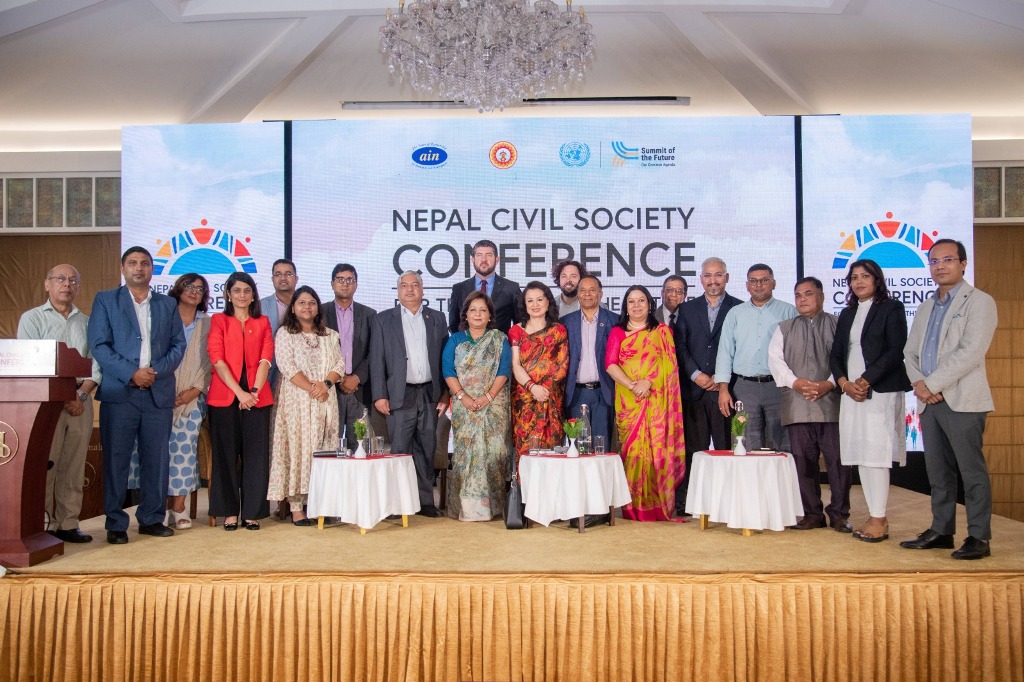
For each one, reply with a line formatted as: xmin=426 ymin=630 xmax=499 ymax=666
xmin=153 ymin=218 xmax=256 ymax=275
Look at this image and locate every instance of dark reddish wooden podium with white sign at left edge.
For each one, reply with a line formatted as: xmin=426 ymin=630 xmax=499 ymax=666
xmin=0 ymin=339 xmax=92 ymax=566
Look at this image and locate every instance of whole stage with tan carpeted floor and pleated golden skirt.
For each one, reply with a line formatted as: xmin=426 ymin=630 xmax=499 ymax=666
xmin=0 ymin=487 xmax=1024 ymax=682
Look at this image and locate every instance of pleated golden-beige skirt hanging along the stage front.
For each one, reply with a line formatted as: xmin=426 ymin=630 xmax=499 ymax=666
xmin=0 ymin=573 xmax=1024 ymax=682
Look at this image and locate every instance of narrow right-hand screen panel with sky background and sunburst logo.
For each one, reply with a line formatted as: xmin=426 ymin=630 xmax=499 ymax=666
xmin=798 ymin=115 xmax=974 ymax=451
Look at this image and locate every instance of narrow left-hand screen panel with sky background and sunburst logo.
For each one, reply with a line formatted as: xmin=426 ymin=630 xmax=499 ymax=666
xmin=121 ymin=123 xmax=285 ymax=312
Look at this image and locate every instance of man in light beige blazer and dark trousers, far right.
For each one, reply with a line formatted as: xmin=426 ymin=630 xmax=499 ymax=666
xmin=900 ymin=240 xmax=997 ymax=559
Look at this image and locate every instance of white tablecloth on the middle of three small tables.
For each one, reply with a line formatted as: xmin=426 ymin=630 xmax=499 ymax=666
xmin=519 ymin=455 xmax=633 ymax=525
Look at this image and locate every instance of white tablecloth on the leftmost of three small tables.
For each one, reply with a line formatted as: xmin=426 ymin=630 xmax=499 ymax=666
xmin=306 ymin=455 xmax=420 ymax=528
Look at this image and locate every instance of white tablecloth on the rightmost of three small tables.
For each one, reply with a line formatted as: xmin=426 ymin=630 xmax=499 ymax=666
xmin=686 ymin=451 xmax=804 ymax=530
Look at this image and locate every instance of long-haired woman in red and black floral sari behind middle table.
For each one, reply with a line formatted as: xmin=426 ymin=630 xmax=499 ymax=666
xmin=509 ymin=282 xmax=569 ymax=455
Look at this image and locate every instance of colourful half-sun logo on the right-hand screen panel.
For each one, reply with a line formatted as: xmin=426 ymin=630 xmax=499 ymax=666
xmin=833 ymin=211 xmax=939 ymax=270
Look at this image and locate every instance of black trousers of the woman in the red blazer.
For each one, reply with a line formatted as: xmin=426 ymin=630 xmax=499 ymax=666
xmin=209 ymin=400 xmax=270 ymax=521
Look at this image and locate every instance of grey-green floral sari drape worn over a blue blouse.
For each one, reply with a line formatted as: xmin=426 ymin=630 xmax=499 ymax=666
xmin=446 ymin=330 xmax=510 ymax=521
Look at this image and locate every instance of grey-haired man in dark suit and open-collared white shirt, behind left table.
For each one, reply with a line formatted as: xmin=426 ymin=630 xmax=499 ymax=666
xmin=370 ymin=270 xmax=449 ymax=517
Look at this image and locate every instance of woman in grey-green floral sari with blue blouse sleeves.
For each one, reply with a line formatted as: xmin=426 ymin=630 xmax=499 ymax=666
xmin=441 ymin=291 xmax=512 ymax=521
